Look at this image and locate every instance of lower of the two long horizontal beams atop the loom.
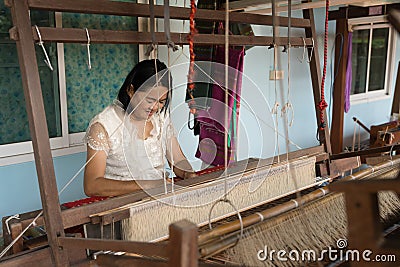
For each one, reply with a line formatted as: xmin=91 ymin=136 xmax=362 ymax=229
xmin=10 ymin=27 xmax=312 ymax=46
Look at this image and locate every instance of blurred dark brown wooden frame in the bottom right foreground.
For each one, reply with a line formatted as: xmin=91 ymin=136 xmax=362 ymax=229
xmin=329 ymin=174 xmax=400 ymax=267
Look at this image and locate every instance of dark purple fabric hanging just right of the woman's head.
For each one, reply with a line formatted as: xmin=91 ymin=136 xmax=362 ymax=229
xmin=196 ymin=47 xmax=244 ymax=165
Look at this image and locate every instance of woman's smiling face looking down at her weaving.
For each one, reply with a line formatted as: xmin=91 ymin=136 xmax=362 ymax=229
xmin=128 ymin=86 xmax=168 ymax=120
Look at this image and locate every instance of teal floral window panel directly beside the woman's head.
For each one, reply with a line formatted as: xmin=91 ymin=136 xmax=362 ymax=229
xmin=63 ymin=14 xmax=138 ymax=133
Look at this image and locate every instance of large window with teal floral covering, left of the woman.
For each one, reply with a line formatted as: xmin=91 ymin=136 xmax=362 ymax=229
xmin=0 ymin=1 xmax=138 ymax=165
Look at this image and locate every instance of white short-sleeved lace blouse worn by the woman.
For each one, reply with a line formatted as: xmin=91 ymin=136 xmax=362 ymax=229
xmin=84 ymin=101 xmax=176 ymax=180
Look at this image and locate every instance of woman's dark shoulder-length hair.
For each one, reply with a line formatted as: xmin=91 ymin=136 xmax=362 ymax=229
xmin=118 ymin=59 xmax=172 ymax=111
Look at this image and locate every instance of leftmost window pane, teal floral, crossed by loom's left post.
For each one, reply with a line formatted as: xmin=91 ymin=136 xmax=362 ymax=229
xmin=0 ymin=2 xmax=62 ymax=156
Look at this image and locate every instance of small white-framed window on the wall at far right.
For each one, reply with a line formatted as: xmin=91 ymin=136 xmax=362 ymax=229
xmin=349 ymin=17 xmax=395 ymax=100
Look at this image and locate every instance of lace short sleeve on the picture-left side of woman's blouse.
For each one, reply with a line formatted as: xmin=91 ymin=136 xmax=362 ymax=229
xmin=84 ymin=122 xmax=110 ymax=155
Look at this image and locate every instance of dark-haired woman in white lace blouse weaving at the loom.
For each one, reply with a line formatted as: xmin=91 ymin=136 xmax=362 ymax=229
xmin=84 ymin=60 xmax=195 ymax=196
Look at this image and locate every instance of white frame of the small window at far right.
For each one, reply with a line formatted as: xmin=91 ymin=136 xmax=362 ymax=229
xmin=348 ymin=15 xmax=396 ymax=104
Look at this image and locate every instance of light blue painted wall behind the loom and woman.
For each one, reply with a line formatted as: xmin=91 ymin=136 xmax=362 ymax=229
xmin=0 ymin=9 xmax=400 ymax=234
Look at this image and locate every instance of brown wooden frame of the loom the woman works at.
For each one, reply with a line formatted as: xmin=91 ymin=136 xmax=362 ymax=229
xmin=0 ymin=0 xmax=394 ymax=266
